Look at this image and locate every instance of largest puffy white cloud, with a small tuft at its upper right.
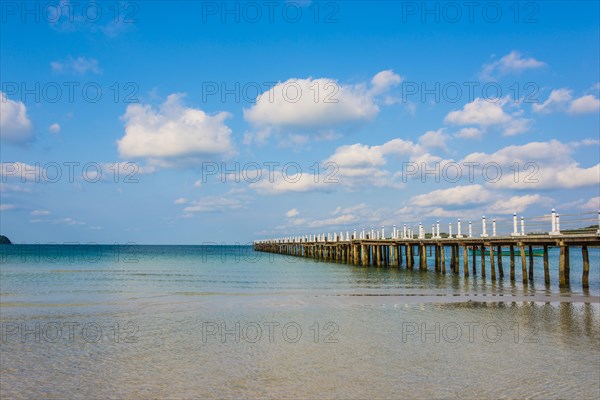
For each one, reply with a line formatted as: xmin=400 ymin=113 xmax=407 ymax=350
xmin=244 ymin=70 xmax=401 ymax=143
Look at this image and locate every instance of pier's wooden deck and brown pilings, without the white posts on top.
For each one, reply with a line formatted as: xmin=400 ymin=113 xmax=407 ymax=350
xmin=254 ymin=232 xmax=600 ymax=288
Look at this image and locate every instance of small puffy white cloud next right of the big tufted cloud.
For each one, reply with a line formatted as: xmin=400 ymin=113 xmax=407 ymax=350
xmin=444 ymin=97 xmax=531 ymax=137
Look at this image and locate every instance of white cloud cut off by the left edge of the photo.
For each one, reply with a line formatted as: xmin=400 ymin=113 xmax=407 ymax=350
xmin=0 ymin=91 xmax=33 ymax=143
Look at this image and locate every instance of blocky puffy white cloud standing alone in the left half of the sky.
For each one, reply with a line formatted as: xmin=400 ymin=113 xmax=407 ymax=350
xmin=117 ymin=94 xmax=234 ymax=166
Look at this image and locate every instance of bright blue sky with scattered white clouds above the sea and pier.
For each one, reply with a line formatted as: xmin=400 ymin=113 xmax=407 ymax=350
xmin=0 ymin=1 xmax=600 ymax=244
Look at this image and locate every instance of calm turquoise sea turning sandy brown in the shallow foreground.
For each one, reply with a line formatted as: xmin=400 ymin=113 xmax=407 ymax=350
xmin=0 ymin=245 xmax=600 ymax=399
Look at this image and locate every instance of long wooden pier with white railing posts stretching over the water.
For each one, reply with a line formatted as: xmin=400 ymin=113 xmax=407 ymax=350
xmin=254 ymin=209 xmax=600 ymax=289
